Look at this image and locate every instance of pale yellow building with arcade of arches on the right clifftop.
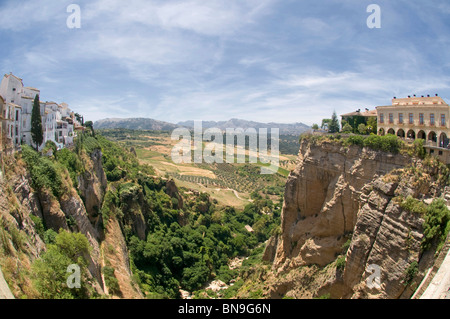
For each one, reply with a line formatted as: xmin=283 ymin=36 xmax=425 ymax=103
xmin=376 ymin=94 xmax=450 ymax=164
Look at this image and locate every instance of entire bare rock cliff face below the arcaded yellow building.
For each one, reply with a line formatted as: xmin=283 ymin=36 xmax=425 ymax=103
xmin=264 ymin=140 xmax=448 ymax=298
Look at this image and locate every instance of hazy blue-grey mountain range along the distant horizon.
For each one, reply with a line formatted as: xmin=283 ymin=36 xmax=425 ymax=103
xmin=94 ymin=118 xmax=311 ymax=135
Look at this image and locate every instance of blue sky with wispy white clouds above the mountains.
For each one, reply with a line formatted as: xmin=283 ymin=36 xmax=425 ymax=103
xmin=0 ymin=0 xmax=450 ymax=125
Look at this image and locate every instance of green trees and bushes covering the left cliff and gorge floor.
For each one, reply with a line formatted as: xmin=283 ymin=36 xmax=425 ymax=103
xmin=3 ymin=132 xmax=280 ymax=298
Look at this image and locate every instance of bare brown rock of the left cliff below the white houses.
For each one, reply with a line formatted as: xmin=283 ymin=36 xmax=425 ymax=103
xmin=0 ymin=150 xmax=142 ymax=298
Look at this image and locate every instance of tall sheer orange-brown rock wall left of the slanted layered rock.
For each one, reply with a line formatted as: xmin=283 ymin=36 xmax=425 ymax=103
xmin=273 ymin=141 xmax=409 ymax=272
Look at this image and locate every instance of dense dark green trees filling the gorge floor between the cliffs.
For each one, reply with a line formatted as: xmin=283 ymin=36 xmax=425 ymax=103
xmin=48 ymin=132 xmax=284 ymax=298
